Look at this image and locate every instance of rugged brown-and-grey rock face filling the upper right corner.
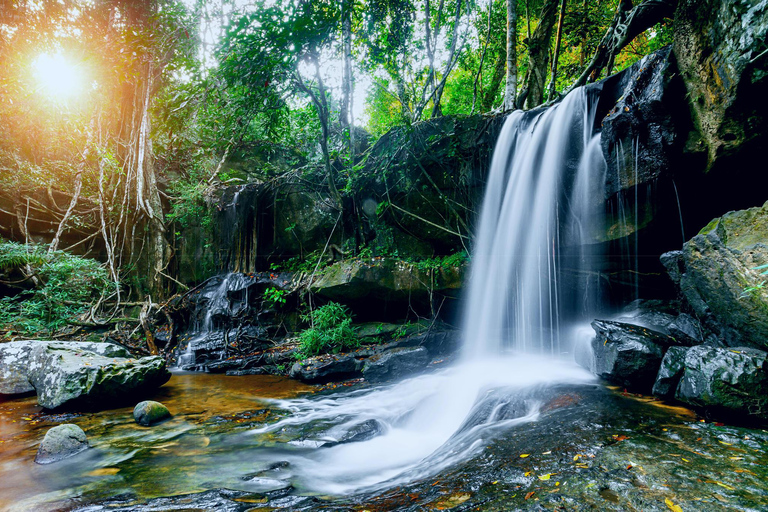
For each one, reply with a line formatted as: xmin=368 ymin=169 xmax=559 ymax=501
xmin=674 ymin=0 xmax=768 ymax=170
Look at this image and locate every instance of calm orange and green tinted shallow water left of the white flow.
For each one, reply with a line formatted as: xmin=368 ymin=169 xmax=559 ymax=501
xmin=0 ymin=374 xmax=312 ymax=511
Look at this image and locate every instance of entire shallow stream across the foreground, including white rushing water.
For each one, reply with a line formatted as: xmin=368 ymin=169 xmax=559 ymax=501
xmin=0 ymin=358 xmax=768 ymax=511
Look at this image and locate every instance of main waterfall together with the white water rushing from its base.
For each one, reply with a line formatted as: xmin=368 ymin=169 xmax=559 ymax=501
xmin=244 ymin=89 xmax=605 ymax=494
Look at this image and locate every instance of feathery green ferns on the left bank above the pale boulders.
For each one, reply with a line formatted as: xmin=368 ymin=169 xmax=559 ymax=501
xmin=0 ymin=242 xmax=113 ymax=334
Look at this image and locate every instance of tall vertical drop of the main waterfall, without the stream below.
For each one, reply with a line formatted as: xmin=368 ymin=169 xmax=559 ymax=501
xmin=463 ymin=88 xmax=606 ymax=358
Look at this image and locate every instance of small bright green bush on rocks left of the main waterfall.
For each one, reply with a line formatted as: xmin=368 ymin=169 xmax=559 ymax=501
xmin=297 ymin=302 xmax=360 ymax=359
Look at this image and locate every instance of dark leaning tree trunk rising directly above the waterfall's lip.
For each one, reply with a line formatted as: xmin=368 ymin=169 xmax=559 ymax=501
xmin=518 ymin=0 xmax=558 ymax=109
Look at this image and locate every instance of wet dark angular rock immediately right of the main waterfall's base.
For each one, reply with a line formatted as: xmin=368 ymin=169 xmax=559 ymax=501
xmin=590 ymin=320 xmax=676 ymax=392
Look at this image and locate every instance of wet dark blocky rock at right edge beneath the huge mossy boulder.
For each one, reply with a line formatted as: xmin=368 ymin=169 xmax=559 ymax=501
xmin=675 ymin=346 xmax=768 ymax=418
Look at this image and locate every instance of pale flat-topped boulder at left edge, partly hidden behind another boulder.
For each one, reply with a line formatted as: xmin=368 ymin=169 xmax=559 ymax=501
xmin=0 ymin=340 xmax=131 ymax=395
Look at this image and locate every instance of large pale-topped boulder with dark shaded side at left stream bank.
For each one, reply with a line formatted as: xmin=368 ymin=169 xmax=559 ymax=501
xmin=28 ymin=343 xmax=171 ymax=409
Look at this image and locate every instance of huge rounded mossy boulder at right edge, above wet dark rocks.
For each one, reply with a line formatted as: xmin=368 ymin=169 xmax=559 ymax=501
xmin=667 ymin=203 xmax=768 ymax=348
